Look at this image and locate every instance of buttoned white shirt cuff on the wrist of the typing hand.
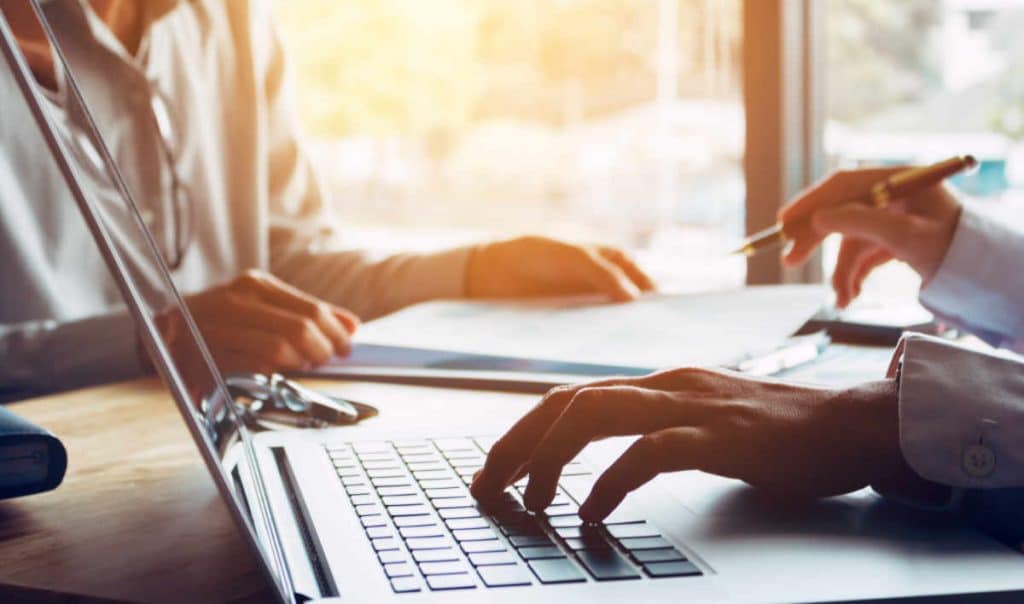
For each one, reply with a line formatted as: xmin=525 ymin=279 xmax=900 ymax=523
xmin=890 ymin=334 xmax=1024 ymax=488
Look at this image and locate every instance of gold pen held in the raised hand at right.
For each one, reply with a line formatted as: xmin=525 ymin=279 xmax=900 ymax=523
xmin=731 ymin=156 xmax=978 ymax=256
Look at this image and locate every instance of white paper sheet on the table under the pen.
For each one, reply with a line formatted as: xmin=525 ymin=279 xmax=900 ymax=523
xmin=355 ymin=286 xmax=825 ymax=369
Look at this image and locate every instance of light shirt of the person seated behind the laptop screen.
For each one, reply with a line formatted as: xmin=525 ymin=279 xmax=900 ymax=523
xmin=0 ymin=0 xmax=468 ymax=401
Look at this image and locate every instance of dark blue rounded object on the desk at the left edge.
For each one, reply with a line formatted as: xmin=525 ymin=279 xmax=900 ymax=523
xmin=0 ymin=406 xmax=68 ymax=500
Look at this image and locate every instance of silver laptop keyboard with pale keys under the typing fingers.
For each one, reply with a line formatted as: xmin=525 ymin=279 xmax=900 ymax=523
xmin=327 ymin=438 xmax=701 ymax=593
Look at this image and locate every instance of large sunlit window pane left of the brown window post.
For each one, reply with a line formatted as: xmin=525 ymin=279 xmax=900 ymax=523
xmin=275 ymin=0 xmax=745 ymax=289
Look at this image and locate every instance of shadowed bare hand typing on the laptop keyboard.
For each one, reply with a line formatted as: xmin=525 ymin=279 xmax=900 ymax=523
xmin=471 ymin=369 xmax=921 ymax=521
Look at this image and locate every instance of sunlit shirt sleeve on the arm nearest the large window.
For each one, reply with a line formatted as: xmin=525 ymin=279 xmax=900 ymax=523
xmin=253 ymin=13 xmax=470 ymax=319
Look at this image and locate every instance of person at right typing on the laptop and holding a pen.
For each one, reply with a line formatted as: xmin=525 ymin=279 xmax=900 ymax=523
xmin=472 ymin=165 xmax=1024 ymax=538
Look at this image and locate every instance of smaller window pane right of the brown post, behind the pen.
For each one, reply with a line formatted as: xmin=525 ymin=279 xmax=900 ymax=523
xmin=824 ymin=0 xmax=1024 ymax=296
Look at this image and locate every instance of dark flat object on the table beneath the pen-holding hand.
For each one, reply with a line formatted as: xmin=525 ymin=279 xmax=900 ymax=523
xmin=797 ymin=306 xmax=945 ymax=346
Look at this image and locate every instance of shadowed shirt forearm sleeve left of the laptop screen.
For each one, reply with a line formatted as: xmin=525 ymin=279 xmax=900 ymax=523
xmin=0 ymin=311 xmax=145 ymax=402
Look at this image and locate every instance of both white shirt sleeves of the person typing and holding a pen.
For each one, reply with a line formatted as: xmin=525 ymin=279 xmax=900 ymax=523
xmin=890 ymin=208 xmax=1024 ymax=488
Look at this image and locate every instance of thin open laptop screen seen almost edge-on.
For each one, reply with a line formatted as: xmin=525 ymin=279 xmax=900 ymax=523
xmin=0 ymin=5 xmax=293 ymax=601
